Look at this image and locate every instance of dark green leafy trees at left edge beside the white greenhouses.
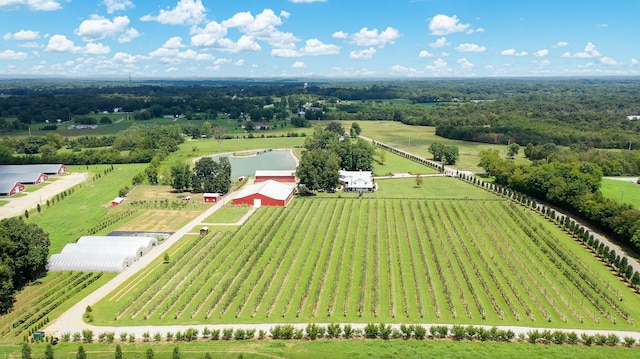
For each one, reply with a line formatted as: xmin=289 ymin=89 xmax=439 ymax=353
xmin=0 ymin=218 xmax=50 ymax=314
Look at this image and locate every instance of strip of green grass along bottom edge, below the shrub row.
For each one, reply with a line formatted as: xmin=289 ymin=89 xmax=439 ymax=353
xmin=0 ymin=339 xmax=638 ymax=359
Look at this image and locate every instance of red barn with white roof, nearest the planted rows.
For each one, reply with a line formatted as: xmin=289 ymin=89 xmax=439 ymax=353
xmin=233 ymin=180 xmax=295 ymax=207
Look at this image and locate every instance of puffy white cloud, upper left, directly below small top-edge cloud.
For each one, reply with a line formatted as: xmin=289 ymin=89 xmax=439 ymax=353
xmin=75 ymin=15 xmax=139 ymax=42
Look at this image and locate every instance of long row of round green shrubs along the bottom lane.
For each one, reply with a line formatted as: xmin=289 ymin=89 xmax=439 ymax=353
xmin=47 ymin=323 xmax=636 ymax=347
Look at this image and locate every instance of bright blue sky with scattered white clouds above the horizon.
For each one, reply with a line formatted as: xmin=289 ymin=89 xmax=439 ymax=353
xmin=0 ymin=0 xmax=640 ymax=79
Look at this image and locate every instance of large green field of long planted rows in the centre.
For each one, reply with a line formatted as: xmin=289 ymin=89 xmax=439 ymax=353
xmin=93 ymin=198 xmax=640 ymax=330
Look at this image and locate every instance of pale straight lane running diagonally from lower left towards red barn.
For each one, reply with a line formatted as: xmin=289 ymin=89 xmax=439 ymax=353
xmin=44 ymin=189 xmax=248 ymax=335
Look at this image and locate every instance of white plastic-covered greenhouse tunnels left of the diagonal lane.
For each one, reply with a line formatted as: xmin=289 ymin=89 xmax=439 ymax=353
xmin=47 ymin=236 xmax=158 ymax=272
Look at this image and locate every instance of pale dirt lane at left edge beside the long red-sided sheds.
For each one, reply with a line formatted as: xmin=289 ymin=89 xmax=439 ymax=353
xmin=0 ymin=172 xmax=88 ymax=219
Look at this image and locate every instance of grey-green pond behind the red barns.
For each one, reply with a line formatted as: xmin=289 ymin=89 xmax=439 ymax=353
xmin=211 ymin=150 xmax=296 ymax=178
